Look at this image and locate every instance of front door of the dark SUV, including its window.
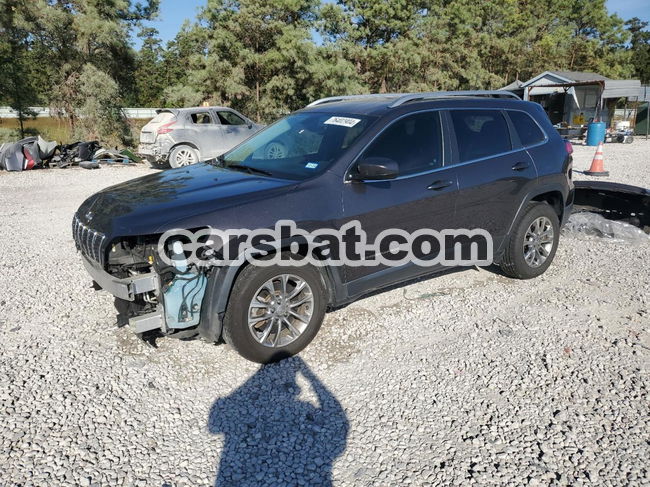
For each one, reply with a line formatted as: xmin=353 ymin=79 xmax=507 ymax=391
xmin=342 ymin=111 xmax=458 ymax=296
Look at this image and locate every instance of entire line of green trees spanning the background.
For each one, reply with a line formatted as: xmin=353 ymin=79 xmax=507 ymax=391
xmin=0 ymin=0 xmax=650 ymax=133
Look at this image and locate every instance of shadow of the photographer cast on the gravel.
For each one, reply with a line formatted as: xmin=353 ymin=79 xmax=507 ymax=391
xmin=208 ymin=357 xmax=348 ymax=487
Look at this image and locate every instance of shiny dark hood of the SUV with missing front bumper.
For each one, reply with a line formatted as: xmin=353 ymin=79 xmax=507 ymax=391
xmin=77 ymin=163 xmax=296 ymax=237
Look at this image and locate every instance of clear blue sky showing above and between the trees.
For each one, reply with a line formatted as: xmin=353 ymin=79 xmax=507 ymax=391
xmin=133 ymin=0 xmax=650 ymax=49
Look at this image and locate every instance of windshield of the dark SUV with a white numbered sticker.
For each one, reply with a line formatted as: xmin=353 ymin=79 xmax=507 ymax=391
xmin=221 ymin=112 xmax=374 ymax=180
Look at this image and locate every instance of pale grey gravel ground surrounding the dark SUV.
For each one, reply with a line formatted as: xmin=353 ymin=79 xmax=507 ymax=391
xmin=0 ymin=141 xmax=650 ymax=486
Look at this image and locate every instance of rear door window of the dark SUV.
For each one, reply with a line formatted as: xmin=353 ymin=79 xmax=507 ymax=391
xmin=450 ymin=110 xmax=512 ymax=162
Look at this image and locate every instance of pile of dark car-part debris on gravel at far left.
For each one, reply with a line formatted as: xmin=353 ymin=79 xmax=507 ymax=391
xmin=0 ymin=136 xmax=141 ymax=171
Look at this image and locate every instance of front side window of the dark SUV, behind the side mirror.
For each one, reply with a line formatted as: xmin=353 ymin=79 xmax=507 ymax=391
xmin=362 ymin=112 xmax=442 ymax=176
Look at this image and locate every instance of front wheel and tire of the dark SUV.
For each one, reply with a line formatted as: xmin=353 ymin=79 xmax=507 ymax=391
xmin=223 ymin=264 xmax=327 ymax=364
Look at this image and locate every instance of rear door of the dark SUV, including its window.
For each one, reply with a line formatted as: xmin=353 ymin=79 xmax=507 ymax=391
xmin=449 ymin=109 xmax=537 ymax=250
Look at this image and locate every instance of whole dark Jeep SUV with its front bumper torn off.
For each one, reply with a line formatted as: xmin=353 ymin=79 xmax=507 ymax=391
xmin=73 ymin=91 xmax=573 ymax=362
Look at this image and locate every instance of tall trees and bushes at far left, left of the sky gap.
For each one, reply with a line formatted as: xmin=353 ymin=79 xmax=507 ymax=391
xmin=0 ymin=0 xmax=159 ymax=143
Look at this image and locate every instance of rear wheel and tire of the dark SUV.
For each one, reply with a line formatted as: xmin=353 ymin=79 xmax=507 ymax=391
xmin=500 ymin=202 xmax=560 ymax=279
